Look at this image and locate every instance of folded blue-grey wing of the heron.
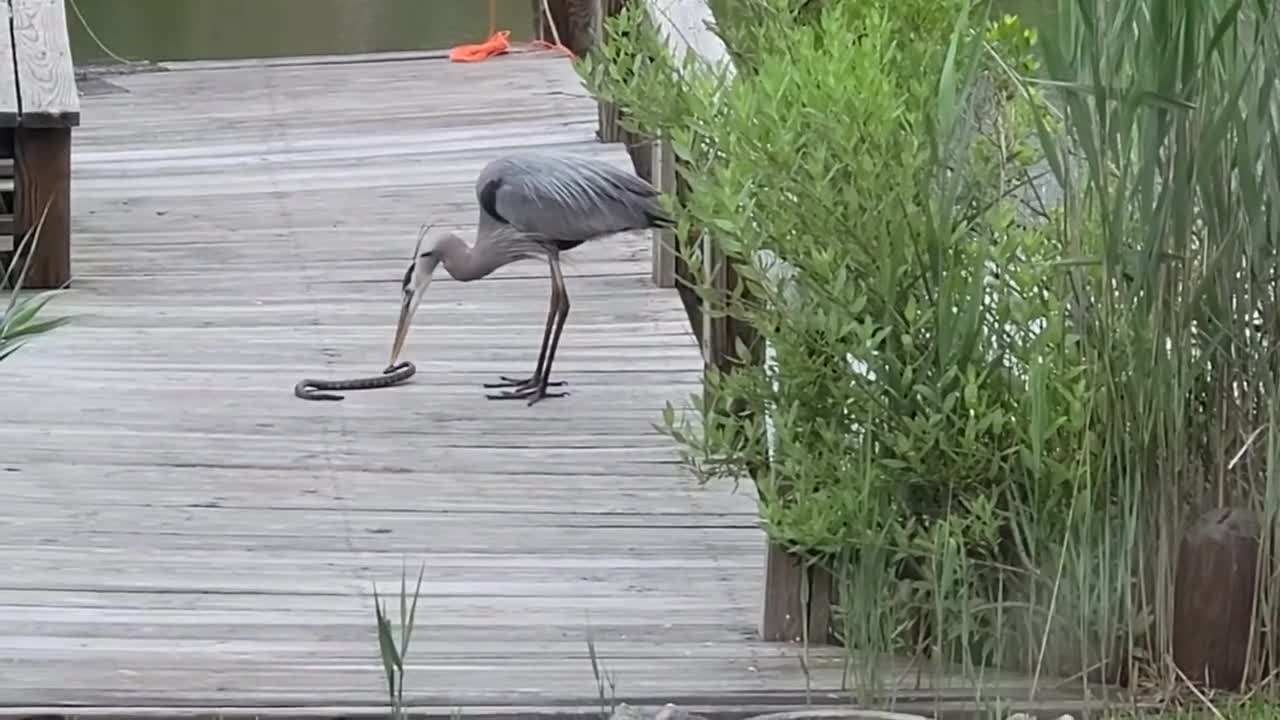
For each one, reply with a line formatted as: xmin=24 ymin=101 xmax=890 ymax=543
xmin=476 ymin=152 xmax=668 ymax=242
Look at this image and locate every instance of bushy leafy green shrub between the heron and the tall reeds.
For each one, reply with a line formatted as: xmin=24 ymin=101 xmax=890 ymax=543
xmin=586 ymin=0 xmax=1084 ymax=670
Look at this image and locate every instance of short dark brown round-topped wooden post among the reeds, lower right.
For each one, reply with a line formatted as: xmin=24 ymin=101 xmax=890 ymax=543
xmin=1172 ymin=509 xmax=1262 ymax=691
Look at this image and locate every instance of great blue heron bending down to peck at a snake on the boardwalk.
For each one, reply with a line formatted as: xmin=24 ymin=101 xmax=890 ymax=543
xmin=390 ymin=152 xmax=671 ymax=405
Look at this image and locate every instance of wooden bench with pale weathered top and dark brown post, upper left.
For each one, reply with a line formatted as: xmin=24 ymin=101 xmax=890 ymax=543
xmin=0 ymin=0 xmax=79 ymax=290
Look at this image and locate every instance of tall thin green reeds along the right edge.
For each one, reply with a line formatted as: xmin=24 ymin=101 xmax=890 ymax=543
xmin=1019 ymin=0 xmax=1280 ymax=683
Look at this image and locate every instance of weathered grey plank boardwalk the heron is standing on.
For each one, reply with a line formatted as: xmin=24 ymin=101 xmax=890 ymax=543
xmin=0 ymin=55 xmax=1049 ymax=717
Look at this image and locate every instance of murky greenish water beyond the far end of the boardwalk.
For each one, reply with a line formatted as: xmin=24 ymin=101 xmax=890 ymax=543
xmin=67 ymin=0 xmax=1053 ymax=63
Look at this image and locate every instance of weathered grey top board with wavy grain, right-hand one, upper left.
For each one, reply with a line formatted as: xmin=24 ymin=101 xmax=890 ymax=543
xmin=9 ymin=0 xmax=81 ymax=128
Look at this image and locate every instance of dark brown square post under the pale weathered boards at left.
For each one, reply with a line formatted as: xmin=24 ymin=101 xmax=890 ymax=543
xmin=13 ymin=127 xmax=72 ymax=290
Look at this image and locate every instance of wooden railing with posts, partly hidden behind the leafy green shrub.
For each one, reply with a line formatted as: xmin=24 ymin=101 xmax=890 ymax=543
xmin=534 ymin=0 xmax=833 ymax=642
